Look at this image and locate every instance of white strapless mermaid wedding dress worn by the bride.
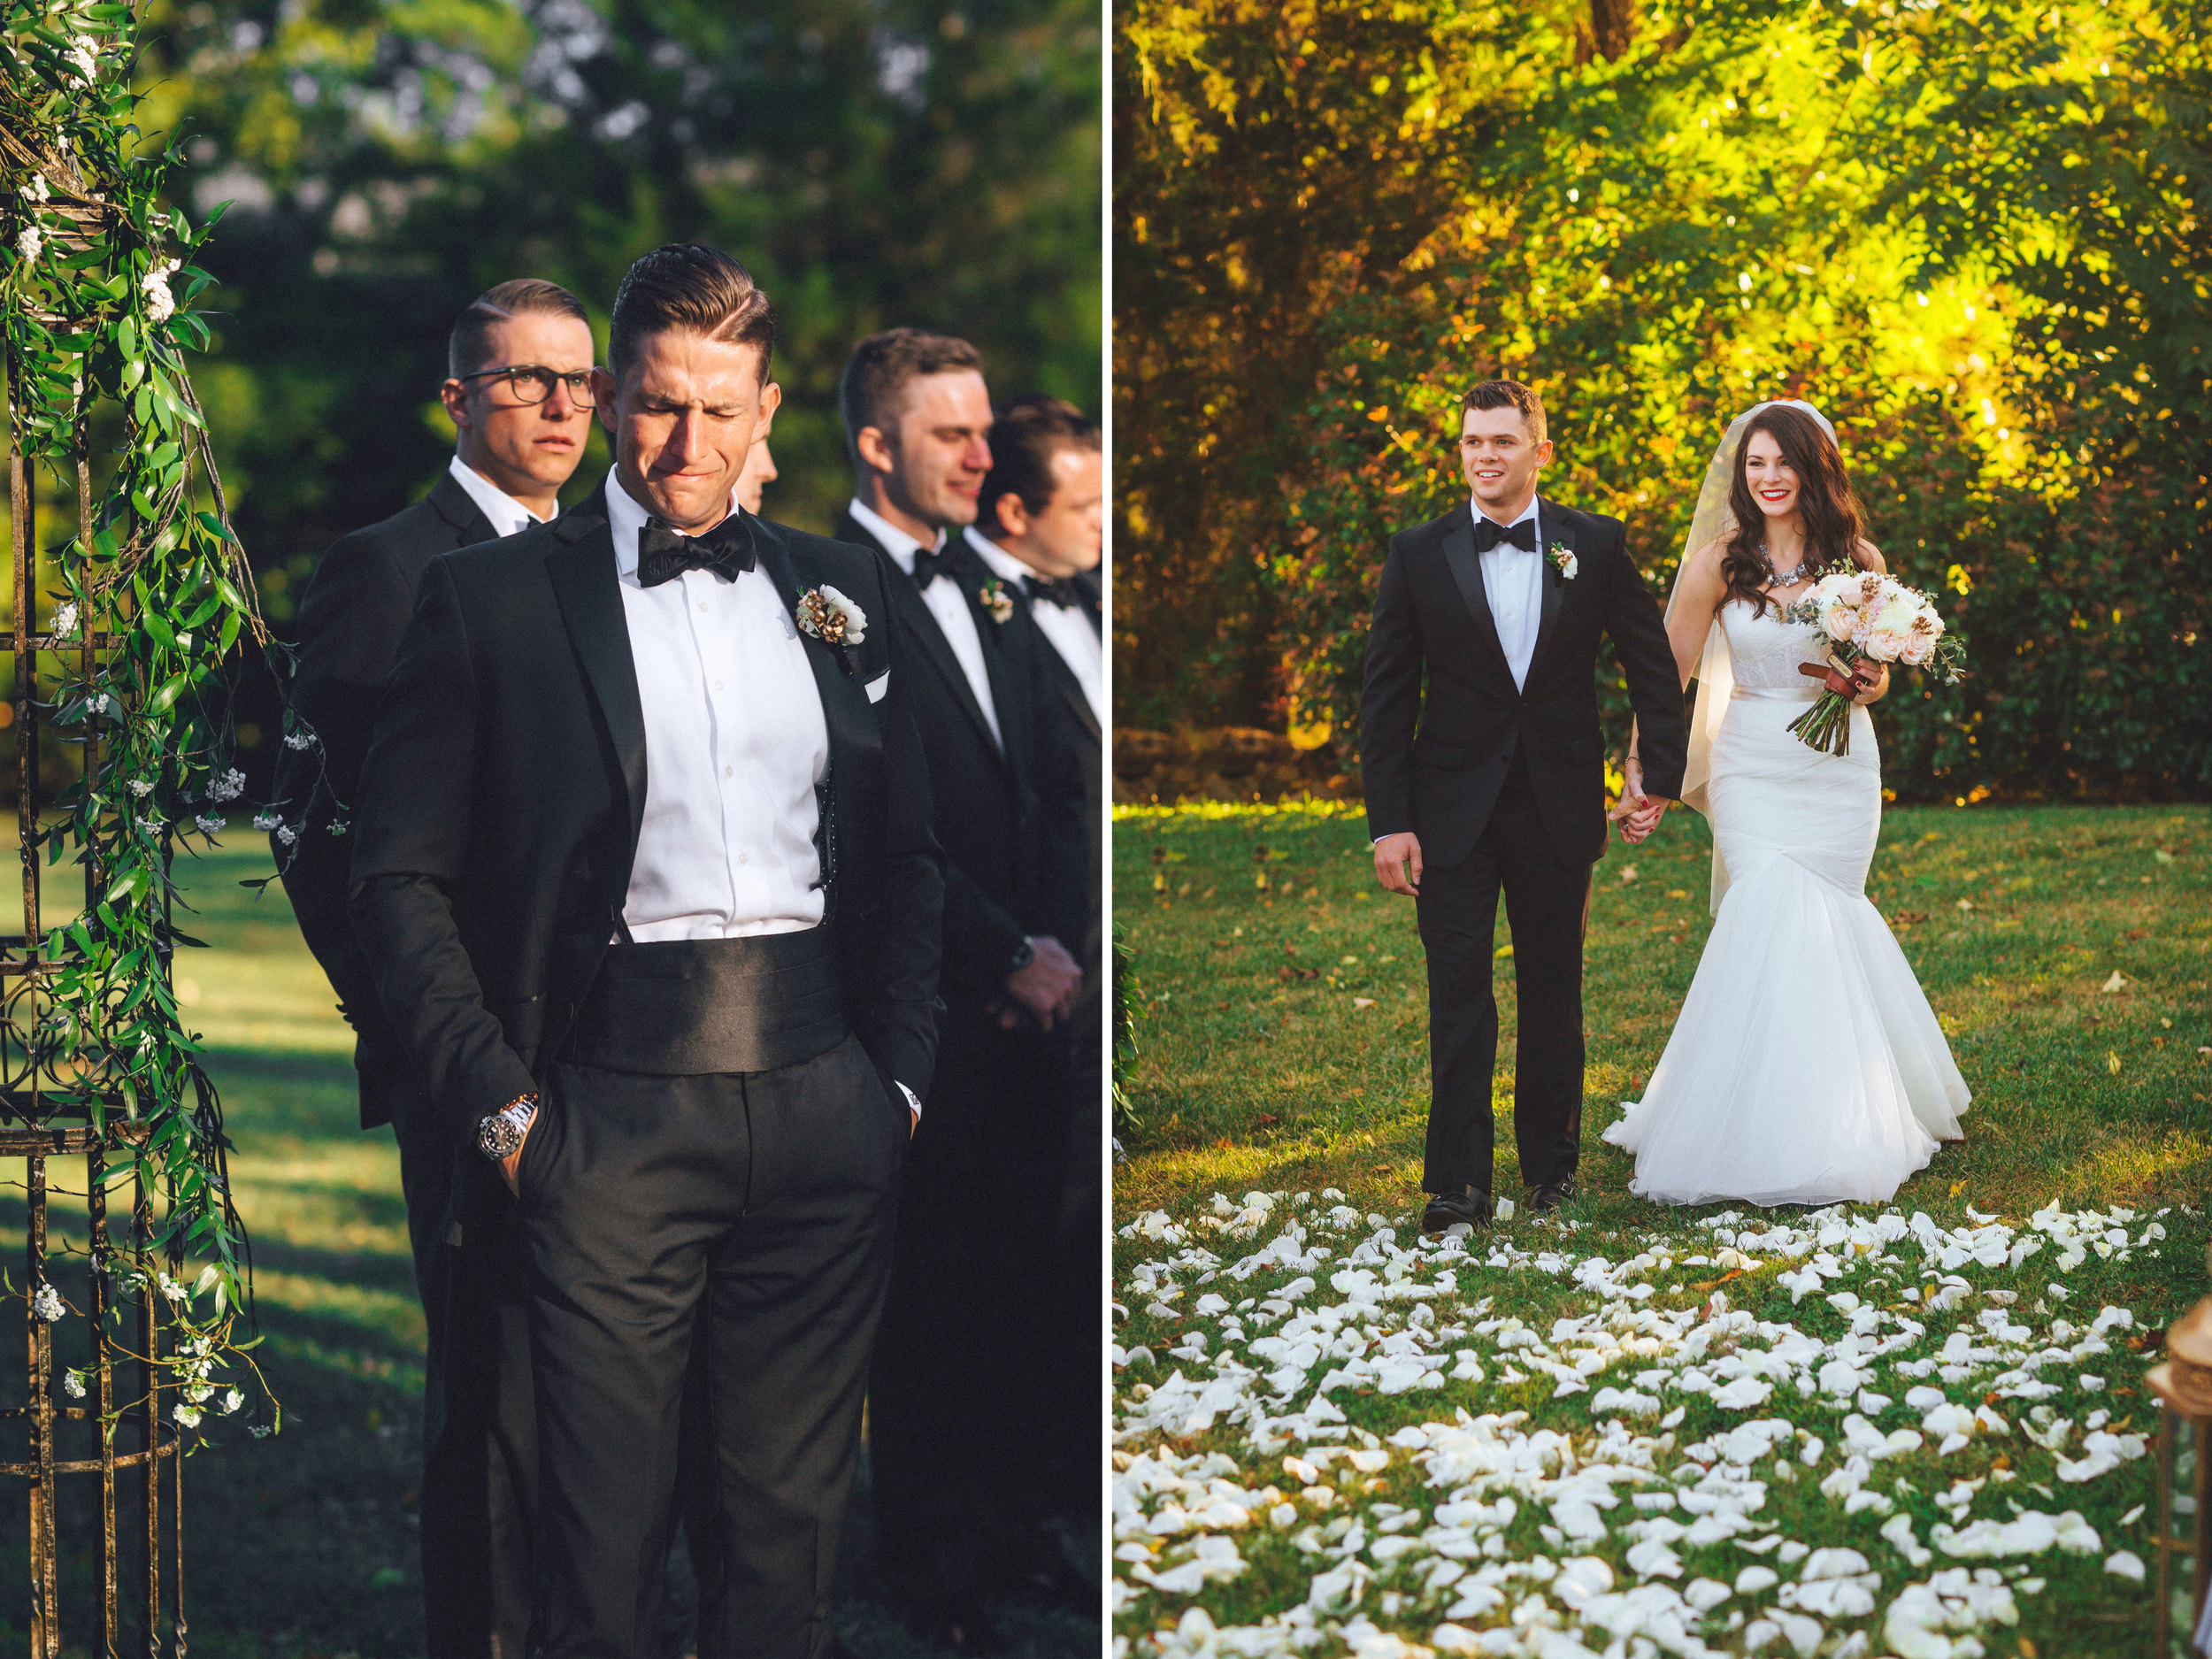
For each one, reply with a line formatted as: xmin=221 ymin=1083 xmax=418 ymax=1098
xmin=1606 ymin=600 xmax=1971 ymax=1203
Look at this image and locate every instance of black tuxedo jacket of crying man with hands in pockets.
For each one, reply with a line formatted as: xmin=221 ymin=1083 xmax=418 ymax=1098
xmin=352 ymin=487 xmax=945 ymax=1188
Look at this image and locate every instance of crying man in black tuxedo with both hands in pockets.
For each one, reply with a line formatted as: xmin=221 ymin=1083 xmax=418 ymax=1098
xmin=352 ymin=246 xmax=942 ymax=1659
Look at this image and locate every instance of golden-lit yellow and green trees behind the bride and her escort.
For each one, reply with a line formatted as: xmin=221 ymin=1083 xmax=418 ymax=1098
xmin=1115 ymin=0 xmax=2212 ymax=799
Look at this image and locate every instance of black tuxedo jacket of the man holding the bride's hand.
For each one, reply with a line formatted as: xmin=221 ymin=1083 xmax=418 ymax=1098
xmin=1361 ymin=500 xmax=1688 ymax=870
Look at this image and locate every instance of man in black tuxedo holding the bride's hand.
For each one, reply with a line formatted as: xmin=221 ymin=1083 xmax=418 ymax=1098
xmin=1361 ymin=380 xmax=1688 ymax=1233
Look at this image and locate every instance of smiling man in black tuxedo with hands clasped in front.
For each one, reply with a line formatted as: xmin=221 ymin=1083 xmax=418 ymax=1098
xmin=839 ymin=330 xmax=1087 ymax=1653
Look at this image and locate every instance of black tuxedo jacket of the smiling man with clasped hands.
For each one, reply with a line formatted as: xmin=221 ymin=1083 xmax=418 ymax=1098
xmin=836 ymin=513 xmax=1084 ymax=1042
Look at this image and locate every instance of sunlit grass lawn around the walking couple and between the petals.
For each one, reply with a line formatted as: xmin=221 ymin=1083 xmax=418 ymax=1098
xmin=1115 ymin=808 xmax=2212 ymax=1657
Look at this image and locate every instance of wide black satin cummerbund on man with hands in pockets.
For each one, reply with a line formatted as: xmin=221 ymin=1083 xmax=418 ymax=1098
xmin=569 ymin=927 xmax=849 ymax=1078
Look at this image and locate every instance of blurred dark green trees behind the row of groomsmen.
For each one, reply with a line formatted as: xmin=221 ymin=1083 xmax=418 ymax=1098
xmin=137 ymin=0 xmax=1102 ymax=631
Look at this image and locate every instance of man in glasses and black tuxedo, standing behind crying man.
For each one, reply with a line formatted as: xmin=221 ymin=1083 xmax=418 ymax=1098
xmin=270 ymin=279 xmax=593 ymax=1659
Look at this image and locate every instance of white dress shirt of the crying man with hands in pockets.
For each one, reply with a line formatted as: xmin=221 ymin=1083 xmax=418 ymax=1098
xmin=606 ymin=473 xmax=830 ymax=942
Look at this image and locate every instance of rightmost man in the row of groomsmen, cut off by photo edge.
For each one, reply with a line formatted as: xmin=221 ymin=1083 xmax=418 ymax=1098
xmin=967 ymin=394 xmax=1106 ymax=1601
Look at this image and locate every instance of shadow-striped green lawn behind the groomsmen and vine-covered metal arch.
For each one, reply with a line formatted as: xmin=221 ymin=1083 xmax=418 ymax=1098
xmin=0 ymin=836 xmax=1095 ymax=1659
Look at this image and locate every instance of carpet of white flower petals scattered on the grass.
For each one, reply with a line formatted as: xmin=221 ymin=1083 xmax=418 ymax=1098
xmin=1113 ymin=1190 xmax=2172 ymax=1659
